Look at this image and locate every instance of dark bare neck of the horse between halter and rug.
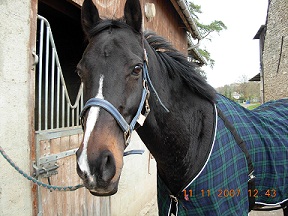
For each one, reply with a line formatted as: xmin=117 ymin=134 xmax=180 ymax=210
xmin=138 ymin=60 xmax=214 ymax=194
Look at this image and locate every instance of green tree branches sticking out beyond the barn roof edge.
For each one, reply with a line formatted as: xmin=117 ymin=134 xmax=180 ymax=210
xmin=189 ymin=2 xmax=227 ymax=68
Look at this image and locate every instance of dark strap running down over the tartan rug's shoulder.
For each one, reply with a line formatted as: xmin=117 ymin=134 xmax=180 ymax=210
xmin=217 ymin=108 xmax=255 ymax=211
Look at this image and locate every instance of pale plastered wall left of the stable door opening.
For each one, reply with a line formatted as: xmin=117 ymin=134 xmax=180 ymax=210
xmin=0 ymin=0 xmax=34 ymax=216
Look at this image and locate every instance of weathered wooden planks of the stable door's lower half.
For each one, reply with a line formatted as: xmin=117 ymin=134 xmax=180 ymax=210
xmin=40 ymin=134 xmax=110 ymax=216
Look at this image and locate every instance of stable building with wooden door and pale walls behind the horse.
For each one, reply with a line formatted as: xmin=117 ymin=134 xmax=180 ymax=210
xmin=0 ymin=0 xmax=205 ymax=216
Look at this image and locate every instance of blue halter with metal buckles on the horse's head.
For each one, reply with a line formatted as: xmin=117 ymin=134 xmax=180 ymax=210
xmin=80 ymin=49 xmax=169 ymax=147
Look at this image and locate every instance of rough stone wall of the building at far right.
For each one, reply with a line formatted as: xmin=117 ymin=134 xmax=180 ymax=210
xmin=263 ymin=0 xmax=288 ymax=102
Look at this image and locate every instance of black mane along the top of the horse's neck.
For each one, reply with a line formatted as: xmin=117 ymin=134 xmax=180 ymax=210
xmin=144 ymin=31 xmax=216 ymax=102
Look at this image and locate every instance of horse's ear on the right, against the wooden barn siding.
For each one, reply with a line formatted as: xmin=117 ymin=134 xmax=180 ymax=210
xmin=124 ymin=0 xmax=142 ymax=32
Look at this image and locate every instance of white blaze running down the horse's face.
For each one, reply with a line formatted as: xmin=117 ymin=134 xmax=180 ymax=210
xmin=78 ymin=75 xmax=104 ymax=176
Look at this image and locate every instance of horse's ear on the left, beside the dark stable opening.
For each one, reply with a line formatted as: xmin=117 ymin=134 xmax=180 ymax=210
xmin=81 ymin=0 xmax=101 ymax=38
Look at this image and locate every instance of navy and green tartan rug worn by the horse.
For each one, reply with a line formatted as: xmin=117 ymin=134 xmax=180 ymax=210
xmin=157 ymin=95 xmax=288 ymax=216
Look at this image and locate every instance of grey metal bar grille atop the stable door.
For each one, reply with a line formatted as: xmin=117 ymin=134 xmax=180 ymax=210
xmin=36 ymin=15 xmax=83 ymax=131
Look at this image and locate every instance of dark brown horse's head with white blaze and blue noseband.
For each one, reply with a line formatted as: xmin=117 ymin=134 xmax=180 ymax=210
xmin=77 ymin=0 xmax=145 ymax=196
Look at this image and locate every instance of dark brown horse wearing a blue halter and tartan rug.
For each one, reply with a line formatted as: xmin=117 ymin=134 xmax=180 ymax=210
xmin=76 ymin=0 xmax=288 ymax=215
